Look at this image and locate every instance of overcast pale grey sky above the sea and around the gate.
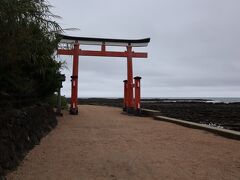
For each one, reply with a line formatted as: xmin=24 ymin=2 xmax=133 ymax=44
xmin=49 ymin=0 xmax=240 ymax=97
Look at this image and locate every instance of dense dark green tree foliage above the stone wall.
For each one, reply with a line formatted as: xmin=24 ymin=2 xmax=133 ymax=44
xmin=0 ymin=0 xmax=62 ymax=106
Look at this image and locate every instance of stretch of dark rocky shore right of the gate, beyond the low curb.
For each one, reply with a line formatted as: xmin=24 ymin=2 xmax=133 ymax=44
xmin=143 ymin=102 xmax=240 ymax=131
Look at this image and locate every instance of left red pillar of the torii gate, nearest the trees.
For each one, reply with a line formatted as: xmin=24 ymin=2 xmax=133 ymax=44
xmin=70 ymin=42 xmax=79 ymax=114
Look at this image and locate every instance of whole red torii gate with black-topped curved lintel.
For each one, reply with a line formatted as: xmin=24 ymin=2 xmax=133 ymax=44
xmin=57 ymin=35 xmax=150 ymax=114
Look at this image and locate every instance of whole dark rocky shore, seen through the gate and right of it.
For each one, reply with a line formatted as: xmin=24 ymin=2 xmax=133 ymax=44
xmin=79 ymin=98 xmax=240 ymax=131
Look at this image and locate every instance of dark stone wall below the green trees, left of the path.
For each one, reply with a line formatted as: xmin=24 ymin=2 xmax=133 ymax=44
xmin=0 ymin=105 xmax=57 ymax=179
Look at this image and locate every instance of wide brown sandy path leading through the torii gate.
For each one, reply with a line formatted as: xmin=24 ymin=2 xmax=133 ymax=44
xmin=7 ymin=105 xmax=240 ymax=180
